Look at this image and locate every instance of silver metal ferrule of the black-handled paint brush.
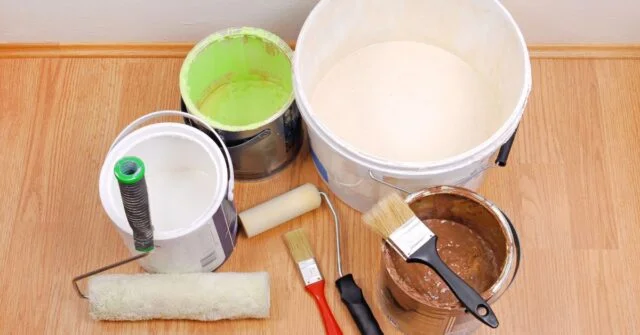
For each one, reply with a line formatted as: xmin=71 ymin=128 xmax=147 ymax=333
xmin=388 ymin=216 xmax=435 ymax=258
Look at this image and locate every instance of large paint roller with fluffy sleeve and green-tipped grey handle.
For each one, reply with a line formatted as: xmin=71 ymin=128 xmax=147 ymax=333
xmin=73 ymin=157 xmax=270 ymax=321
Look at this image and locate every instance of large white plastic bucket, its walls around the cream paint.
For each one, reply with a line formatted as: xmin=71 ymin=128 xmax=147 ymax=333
xmin=293 ymin=0 xmax=531 ymax=211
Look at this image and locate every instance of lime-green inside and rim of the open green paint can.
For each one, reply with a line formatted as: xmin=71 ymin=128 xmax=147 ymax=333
xmin=180 ymin=28 xmax=293 ymax=131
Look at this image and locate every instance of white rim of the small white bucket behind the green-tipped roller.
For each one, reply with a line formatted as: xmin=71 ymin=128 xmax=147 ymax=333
xmin=99 ymin=122 xmax=229 ymax=241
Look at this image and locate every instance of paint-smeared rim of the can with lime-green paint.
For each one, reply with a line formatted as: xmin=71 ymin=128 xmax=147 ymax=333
xmin=179 ymin=26 xmax=295 ymax=132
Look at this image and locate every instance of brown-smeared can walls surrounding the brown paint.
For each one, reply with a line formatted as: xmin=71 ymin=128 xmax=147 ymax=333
xmin=379 ymin=186 xmax=520 ymax=334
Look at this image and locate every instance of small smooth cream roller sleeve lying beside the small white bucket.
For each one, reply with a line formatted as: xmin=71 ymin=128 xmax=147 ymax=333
xmin=238 ymin=184 xmax=322 ymax=237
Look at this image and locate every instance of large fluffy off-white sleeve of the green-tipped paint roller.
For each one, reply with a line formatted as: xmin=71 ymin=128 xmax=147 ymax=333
xmin=88 ymin=272 xmax=270 ymax=321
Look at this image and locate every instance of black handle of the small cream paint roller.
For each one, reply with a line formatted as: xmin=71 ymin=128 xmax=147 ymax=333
xmin=336 ymin=274 xmax=383 ymax=335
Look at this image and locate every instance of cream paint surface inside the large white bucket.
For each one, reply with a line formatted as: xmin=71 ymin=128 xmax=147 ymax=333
xmin=311 ymin=41 xmax=505 ymax=162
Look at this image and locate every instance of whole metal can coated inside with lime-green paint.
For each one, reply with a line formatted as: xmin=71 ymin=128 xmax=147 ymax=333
xmin=180 ymin=27 xmax=303 ymax=179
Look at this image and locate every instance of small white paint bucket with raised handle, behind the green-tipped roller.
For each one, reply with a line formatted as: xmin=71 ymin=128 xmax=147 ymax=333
xmin=99 ymin=111 xmax=238 ymax=273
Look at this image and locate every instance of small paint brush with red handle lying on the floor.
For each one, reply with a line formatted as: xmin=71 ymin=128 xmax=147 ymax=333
xmin=284 ymin=228 xmax=342 ymax=335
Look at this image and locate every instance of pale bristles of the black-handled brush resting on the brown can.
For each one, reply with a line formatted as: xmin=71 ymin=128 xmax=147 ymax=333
xmin=362 ymin=193 xmax=416 ymax=239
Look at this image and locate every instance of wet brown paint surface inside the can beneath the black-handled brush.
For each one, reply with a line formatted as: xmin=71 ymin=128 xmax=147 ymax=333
xmin=390 ymin=219 xmax=499 ymax=308
